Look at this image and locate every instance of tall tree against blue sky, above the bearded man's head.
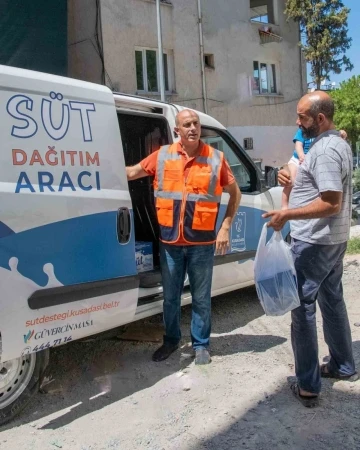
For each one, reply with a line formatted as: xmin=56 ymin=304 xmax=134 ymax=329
xmin=285 ymin=0 xmax=354 ymax=89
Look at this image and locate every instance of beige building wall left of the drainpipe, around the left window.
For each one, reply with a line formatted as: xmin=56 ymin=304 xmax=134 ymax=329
xmin=101 ymin=0 xmax=202 ymax=109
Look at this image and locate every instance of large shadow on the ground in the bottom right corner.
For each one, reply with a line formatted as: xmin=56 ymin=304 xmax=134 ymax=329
xmin=191 ymin=341 xmax=360 ymax=450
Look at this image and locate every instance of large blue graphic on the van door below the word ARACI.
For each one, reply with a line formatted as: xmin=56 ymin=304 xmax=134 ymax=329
xmin=0 ymin=211 xmax=136 ymax=288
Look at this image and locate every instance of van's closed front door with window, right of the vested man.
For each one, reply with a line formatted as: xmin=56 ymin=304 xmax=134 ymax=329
xmin=201 ymin=125 xmax=274 ymax=295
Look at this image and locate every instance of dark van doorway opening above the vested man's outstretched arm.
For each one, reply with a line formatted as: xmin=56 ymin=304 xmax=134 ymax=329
xmin=118 ymin=112 xmax=170 ymax=166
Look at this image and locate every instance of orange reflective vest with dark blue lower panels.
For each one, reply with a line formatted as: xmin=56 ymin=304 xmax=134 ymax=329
xmin=154 ymin=144 xmax=224 ymax=244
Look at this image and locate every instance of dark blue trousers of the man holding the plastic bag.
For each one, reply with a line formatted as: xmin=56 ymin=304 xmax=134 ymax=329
xmin=291 ymin=239 xmax=355 ymax=393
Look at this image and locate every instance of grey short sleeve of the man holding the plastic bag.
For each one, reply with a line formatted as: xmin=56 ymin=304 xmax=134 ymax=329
xmin=312 ymin=147 xmax=343 ymax=192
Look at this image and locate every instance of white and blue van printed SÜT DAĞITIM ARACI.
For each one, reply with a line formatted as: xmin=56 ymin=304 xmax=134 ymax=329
xmin=0 ymin=66 xmax=281 ymax=423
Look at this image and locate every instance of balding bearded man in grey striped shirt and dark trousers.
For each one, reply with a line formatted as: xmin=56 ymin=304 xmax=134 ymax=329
xmin=263 ymin=91 xmax=358 ymax=407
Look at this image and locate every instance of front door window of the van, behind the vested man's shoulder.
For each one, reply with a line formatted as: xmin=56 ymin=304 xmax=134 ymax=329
xmin=201 ymin=127 xmax=256 ymax=192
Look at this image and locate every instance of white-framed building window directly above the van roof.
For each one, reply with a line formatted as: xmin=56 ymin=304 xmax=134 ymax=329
xmin=135 ymin=48 xmax=174 ymax=93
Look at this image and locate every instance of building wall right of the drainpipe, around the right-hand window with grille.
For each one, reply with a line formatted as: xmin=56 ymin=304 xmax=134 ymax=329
xmin=203 ymin=0 xmax=302 ymax=126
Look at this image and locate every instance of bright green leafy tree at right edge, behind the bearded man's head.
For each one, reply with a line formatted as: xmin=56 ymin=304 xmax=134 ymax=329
xmin=330 ymin=75 xmax=360 ymax=151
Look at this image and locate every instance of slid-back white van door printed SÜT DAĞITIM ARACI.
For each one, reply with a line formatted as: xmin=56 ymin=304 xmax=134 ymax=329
xmin=0 ymin=66 xmax=139 ymax=366
